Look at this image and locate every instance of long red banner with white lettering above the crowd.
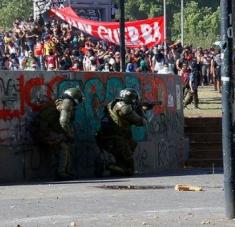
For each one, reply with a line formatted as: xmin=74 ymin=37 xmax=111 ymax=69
xmin=51 ymin=7 xmax=164 ymax=47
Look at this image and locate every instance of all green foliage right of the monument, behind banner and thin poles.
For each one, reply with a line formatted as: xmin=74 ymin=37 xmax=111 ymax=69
xmin=113 ymin=0 xmax=220 ymax=47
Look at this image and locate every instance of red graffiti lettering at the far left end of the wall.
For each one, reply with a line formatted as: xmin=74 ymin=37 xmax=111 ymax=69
xmin=0 ymin=75 xmax=64 ymax=119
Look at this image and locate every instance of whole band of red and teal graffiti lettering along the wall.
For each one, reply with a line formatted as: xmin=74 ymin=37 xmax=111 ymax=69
xmin=0 ymin=73 xmax=177 ymax=141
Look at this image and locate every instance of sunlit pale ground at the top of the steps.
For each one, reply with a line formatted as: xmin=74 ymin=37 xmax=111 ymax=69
xmin=184 ymin=86 xmax=222 ymax=117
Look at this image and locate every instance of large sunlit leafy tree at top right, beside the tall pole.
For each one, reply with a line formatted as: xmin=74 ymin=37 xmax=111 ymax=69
xmin=172 ymin=1 xmax=220 ymax=48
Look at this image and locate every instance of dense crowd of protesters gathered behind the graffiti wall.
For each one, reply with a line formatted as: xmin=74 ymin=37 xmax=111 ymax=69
xmin=0 ymin=17 xmax=221 ymax=91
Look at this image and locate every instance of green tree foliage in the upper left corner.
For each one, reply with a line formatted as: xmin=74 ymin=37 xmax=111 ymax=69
xmin=0 ymin=0 xmax=33 ymax=28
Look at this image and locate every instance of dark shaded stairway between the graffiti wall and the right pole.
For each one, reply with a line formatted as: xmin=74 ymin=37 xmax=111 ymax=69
xmin=184 ymin=117 xmax=223 ymax=168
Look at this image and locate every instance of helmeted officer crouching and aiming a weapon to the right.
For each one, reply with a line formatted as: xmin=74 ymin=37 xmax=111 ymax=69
xmin=96 ymin=88 xmax=153 ymax=176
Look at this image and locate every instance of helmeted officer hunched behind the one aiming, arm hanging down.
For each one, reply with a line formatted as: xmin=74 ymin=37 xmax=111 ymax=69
xmin=36 ymin=88 xmax=84 ymax=180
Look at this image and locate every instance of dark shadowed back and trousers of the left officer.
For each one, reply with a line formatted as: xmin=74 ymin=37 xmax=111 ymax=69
xmin=32 ymin=99 xmax=74 ymax=179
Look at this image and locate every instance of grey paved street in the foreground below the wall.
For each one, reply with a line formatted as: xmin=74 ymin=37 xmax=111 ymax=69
xmin=0 ymin=169 xmax=235 ymax=227
